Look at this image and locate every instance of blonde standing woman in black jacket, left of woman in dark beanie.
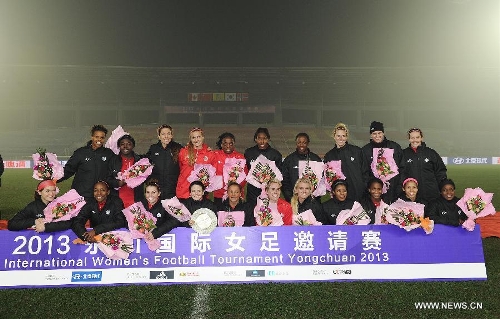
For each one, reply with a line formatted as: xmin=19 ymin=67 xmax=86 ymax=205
xmin=324 ymin=123 xmax=370 ymax=201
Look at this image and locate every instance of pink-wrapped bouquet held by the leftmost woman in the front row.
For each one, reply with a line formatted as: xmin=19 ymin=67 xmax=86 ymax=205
xmin=43 ymin=189 xmax=85 ymax=223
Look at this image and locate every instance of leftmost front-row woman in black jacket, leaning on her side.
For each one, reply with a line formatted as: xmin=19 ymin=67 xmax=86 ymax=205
xmin=7 ymin=180 xmax=72 ymax=233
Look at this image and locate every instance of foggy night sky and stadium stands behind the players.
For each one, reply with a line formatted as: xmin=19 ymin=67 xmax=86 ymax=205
xmin=0 ymin=0 xmax=500 ymax=160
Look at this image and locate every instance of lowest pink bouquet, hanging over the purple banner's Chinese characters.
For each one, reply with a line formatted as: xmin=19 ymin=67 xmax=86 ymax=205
xmin=97 ymin=231 xmax=134 ymax=259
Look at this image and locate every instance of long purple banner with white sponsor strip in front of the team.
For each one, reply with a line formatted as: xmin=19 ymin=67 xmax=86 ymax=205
xmin=0 ymin=225 xmax=486 ymax=288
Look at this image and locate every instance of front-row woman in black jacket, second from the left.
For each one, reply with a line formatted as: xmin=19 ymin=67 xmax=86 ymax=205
xmin=72 ymin=181 xmax=127 ymax=243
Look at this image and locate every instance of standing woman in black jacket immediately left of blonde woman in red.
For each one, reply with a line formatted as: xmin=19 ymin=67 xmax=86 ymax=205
xmin=146 ymin=124 xmax=182 ymax=199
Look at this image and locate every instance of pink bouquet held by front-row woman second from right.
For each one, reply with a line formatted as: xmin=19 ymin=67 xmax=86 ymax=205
xmin=385 ymin=199 xmax=434 ymax=234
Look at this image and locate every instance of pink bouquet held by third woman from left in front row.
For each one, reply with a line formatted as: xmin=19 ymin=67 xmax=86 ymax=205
xmin=122 ymin=202 xmax=161 ymax=251
